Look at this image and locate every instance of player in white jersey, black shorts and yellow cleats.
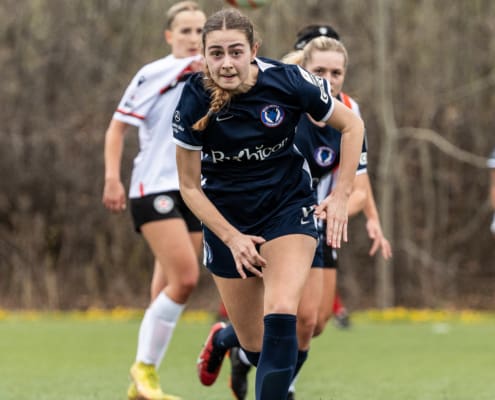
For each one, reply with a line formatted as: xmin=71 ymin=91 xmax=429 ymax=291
xmin=103 ymin=1 xmax=206 ymax=400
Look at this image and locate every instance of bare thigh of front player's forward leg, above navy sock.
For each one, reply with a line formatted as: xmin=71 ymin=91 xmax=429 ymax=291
xmin=260 ymin=234 xmax=316 ymax=314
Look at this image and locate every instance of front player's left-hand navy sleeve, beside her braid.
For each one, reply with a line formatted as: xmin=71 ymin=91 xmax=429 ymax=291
xmin=172 ymin=74 xmax=208 ymax=150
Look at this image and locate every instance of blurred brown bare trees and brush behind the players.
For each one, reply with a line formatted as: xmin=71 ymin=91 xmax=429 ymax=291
xmin=0 ymin=0 xmax=495 ymax=308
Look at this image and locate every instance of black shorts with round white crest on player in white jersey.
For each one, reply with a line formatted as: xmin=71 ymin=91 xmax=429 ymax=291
xmin=131 ymin=190 xmax=202 ymax=232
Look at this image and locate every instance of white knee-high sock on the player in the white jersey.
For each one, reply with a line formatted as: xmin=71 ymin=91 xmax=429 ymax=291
xmin=136 ymin=292 xmax=185 ymax=369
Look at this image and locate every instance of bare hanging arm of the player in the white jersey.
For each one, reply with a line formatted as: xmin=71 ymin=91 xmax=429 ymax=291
xmin=102 ymin=119 xmax=129 ymax=212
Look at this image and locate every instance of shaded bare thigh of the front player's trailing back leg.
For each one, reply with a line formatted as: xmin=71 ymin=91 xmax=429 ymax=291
xmin=213 ymin=275 xmax=263 ymax=351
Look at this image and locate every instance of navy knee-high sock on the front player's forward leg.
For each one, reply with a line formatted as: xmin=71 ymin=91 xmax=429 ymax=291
xmin=256 ymin=314 xmax=297 ymax=400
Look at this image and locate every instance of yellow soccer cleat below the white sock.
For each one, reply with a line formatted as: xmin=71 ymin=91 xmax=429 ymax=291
xmin=127 ymin=362 xmax=180 ymax=400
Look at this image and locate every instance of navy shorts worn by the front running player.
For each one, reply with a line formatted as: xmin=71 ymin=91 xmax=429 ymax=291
xmin=203 ymin=205 xmax=318 ymax=278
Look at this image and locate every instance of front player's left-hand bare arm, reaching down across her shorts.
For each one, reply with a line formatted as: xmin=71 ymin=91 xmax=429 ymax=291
xmin=176 ymin=146 xmax=266 ymax=278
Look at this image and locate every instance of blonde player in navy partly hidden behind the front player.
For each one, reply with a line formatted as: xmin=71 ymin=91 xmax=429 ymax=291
xmin=230 ymin=25 xmax=391 ymax=400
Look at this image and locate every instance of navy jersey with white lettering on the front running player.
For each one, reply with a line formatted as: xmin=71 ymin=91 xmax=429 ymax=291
xmin=173 ymin=58 xmax=333 ymax=234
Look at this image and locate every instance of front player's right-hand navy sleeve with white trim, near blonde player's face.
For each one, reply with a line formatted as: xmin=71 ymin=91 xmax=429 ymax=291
xmin=288 ymin=65 xmax=334 ymax=121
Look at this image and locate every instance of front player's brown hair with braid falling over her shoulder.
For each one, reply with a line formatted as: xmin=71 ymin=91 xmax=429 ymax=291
xmin=193 ymin=8 xmax=255 ymax=131
